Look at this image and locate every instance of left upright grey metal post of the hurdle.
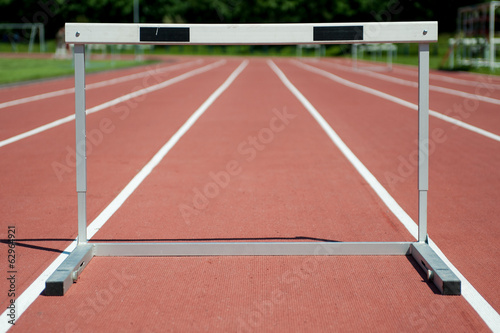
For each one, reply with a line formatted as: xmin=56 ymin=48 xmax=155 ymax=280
xmin=74 ymin=44 xmax=87 ymax=244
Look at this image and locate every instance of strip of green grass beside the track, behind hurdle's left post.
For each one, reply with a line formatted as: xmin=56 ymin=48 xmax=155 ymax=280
xmin=0 ymin=58 xmax=158 ymax=84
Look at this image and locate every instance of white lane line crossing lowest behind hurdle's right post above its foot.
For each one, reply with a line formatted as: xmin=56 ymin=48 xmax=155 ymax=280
xmin=292 ymin=60 xmax=500 ymax=142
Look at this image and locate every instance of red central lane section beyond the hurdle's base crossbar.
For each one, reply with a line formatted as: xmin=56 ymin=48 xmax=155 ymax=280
xmin=89 ymin=60 xmax=412 ymax=241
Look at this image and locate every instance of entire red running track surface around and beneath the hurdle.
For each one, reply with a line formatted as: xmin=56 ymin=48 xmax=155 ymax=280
xmin=0 ymin=57 xmax=500 ymax=332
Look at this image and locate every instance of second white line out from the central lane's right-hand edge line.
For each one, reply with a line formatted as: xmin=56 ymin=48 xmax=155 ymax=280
xmin=320 ymin=62 xmax=500 ymax=105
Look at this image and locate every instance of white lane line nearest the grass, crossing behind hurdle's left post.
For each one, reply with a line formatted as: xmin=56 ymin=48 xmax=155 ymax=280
xmin=0 ymin=59 xmax=203 ymax=109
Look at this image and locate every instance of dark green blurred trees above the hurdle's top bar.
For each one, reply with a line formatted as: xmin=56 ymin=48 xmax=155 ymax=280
xmin=0 ymin=0 xmax=481 ymax=38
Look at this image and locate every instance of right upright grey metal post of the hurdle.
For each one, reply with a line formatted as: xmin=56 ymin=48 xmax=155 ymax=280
xmin=418 ymin=44 xmax=429 ymax=243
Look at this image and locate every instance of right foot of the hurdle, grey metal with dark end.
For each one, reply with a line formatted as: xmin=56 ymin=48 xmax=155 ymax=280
xmin=410 ymin=242 xmax=462 ymax=295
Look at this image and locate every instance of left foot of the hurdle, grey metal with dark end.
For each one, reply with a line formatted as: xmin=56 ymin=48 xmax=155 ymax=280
xmin=44 ymin=244 xmax=94 ymax=296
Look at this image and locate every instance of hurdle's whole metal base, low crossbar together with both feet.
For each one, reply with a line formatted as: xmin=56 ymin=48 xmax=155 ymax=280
xmin=45 ymin=242 xmax=460 ymax=296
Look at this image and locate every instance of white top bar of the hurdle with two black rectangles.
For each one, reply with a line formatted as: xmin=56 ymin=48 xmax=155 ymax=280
xmin=66 ymin=21 xmax=438 ymax=45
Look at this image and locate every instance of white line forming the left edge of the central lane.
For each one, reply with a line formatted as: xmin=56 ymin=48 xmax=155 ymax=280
xmin=0 ymin=60 xmax=248 ymax=332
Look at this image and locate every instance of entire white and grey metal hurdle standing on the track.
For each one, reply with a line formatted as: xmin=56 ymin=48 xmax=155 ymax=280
xmin=45 ymin=22 xmax=461 ymax=296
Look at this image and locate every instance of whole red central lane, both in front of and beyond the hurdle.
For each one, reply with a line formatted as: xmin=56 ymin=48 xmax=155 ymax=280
xmin=9 ymin=59 xmax=486 ymax=332
